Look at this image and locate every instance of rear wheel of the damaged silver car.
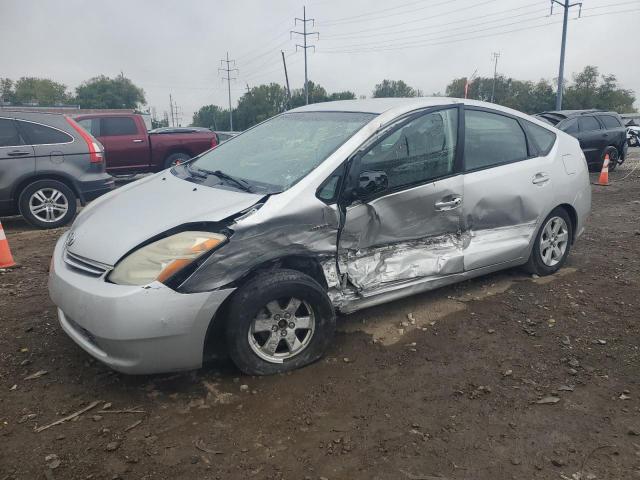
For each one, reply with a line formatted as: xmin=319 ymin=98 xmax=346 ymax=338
xmin=525 ymin=207 xmax=573 ymax=276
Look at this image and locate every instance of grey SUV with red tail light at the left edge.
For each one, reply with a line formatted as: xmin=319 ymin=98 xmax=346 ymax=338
xmin=0 ymin=109 xmax=114 ymax=228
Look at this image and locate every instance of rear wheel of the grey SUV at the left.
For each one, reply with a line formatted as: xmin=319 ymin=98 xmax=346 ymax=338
xmin=18 ymin=180 xmax=78 ymax=228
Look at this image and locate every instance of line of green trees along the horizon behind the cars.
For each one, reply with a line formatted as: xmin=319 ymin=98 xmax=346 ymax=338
xmin=0 ymin=65 xmax=635 ymax=130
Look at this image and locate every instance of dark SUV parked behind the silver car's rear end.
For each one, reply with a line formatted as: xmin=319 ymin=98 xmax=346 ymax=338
xmin=536 ymin=110 xmax=627 ymax=171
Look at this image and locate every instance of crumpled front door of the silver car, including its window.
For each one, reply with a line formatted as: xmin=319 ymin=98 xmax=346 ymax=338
xmin=338 ymin=106 xmax=464 ymax=296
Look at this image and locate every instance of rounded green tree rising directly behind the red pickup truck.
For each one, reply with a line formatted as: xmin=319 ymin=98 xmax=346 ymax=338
xmin=75 ymin=75 xmax=146 ymax=108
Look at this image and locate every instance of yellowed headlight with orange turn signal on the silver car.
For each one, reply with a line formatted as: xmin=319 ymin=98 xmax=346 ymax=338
xmin=109 ymin=232 xmax=227 ymax=285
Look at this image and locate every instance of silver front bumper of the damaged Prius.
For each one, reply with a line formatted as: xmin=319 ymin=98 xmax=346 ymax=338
xmin=49 ymin=234 xmax=233 ymax=374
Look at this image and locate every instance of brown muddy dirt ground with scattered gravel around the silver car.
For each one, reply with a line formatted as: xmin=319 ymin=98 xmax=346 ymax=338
xmin=0 ymin=153 xmax=640 ymax=480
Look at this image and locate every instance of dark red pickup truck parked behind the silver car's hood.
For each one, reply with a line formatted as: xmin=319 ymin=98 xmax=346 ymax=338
xmin=74 ymin=113 xmax=218 ymax=175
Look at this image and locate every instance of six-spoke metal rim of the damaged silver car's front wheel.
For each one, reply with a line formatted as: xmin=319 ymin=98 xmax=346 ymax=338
xmin=248 ymin=297 xmax=315 ymax=363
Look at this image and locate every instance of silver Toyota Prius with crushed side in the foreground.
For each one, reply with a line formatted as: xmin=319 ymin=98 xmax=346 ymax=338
xmin=49 ymin=98 xmax=591 ymax=375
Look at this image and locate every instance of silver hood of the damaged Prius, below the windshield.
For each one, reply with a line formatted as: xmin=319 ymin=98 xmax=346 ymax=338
xmin=67 ymin=171 xmax=263 ymax=265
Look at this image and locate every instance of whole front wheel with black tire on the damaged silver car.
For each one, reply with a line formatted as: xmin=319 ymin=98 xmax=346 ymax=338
xmin=226 ymin=269 xmax=336 ymax=375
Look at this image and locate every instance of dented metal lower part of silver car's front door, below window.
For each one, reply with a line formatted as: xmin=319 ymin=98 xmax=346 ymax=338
xmin=338 ymin=175 xmax=464 ymax=294
